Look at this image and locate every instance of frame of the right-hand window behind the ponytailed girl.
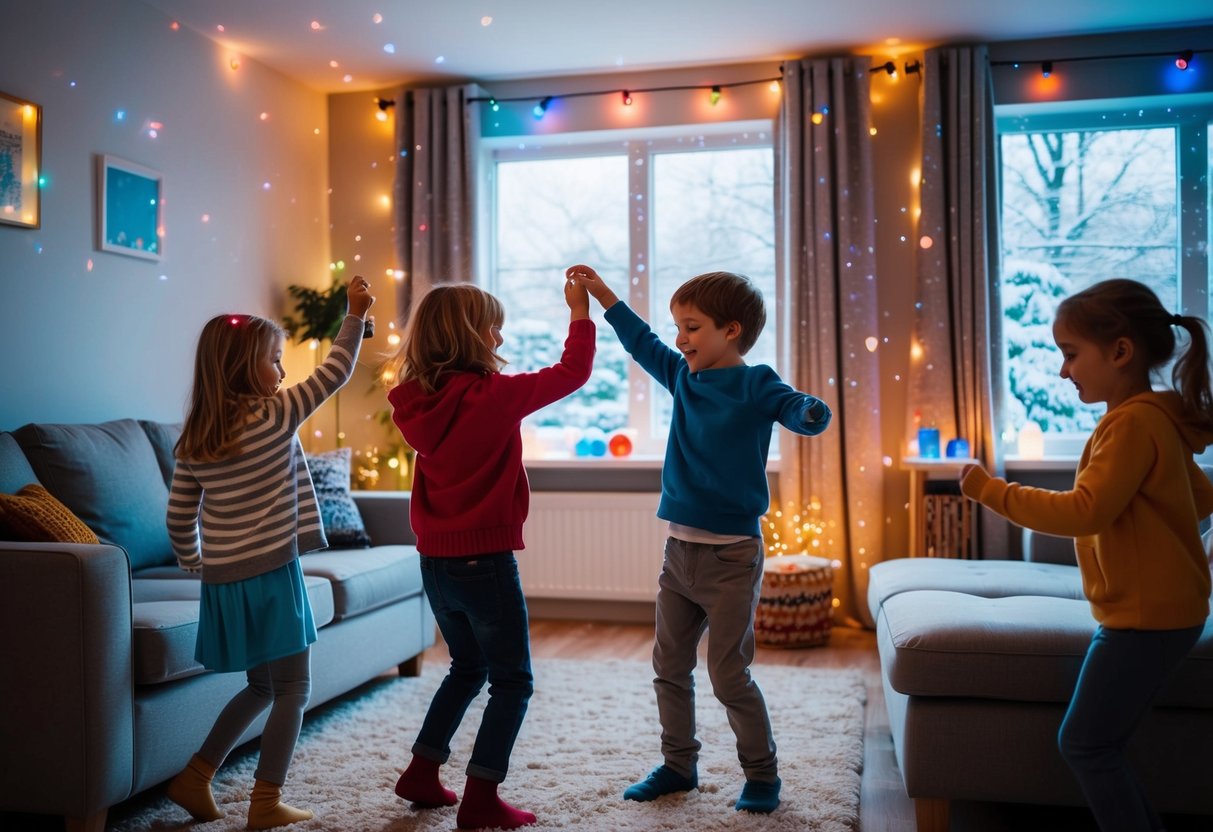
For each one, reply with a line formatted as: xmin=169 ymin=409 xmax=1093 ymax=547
xmin=995 ymin=93 xmax=1213 ymax=467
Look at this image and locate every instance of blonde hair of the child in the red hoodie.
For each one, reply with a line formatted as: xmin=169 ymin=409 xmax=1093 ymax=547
xmin=382 ymin=283 xmax=507 ymax=393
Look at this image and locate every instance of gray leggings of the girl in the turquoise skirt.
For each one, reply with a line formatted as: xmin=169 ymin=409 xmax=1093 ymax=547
xmin=198 ymin=648 xmax=312 ymax=786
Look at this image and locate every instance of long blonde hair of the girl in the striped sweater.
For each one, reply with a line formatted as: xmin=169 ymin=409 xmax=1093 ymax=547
xmin=173 ymin=314 xmax=285 ymax=462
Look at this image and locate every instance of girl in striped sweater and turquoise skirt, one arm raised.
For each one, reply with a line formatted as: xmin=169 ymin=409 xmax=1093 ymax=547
xmin=167 ymin=277 xmax=375 ymax=830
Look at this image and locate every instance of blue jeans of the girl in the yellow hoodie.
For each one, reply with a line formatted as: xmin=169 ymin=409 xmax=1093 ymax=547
xmin=1058 ymin=626 xmax=1205 ymax=832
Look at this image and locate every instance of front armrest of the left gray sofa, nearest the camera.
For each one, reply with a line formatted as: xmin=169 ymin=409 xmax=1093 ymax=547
xmin=0 ymin=542 xmax=135 ymax=817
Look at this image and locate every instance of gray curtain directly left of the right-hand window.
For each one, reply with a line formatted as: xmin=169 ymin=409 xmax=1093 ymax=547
xmin=909 ymin=46 xmax=1007 ymax=558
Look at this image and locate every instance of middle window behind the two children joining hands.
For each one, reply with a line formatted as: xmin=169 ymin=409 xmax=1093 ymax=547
xmin=482 ymin=122 xmax=776 ymax=456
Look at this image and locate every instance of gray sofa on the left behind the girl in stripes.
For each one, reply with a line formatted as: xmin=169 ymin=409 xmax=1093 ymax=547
xmin=0 ymin=420 xmax=434 ymax=832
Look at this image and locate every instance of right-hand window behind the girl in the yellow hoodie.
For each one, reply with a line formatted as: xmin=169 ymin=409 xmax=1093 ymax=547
xmin=997 ymin=98 xmax=1213 ymax=456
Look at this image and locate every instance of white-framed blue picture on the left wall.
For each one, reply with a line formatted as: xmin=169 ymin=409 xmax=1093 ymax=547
xmin=97 ymin=155 xmax=164 ymax=261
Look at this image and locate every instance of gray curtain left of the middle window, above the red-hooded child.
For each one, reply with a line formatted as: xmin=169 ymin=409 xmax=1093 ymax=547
xmin=393 ymin=85 xmax=480 ymax=326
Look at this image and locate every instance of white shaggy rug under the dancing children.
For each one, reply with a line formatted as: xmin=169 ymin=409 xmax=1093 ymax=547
xmin=108 ymin=659 xmax=865 ymax=832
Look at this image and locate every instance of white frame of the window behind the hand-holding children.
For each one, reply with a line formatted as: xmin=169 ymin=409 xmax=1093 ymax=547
xmin=475 ymin=119 xmax=785 ymax=468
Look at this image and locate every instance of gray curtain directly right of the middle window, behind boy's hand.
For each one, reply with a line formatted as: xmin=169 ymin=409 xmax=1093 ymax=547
xmin=775 ymin=57 xmax=884 ymax=626
